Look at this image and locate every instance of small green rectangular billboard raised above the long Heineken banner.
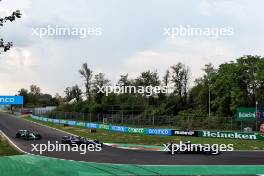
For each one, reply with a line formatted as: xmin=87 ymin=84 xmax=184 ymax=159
xmin=236 ymin=108 xmax=256 ymax=121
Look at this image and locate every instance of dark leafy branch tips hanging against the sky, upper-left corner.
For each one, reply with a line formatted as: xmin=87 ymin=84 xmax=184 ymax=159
xmin=0 ymin=0 xmax=22 ymax=54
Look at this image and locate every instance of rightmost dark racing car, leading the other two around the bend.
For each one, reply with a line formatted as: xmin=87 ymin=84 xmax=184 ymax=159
xmin=167 ymin=141 xmax=220 ymax=155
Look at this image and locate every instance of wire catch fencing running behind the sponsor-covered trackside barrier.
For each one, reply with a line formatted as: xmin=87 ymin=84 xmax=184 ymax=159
xmin=33 ymin=110 xmax=255 ymax=131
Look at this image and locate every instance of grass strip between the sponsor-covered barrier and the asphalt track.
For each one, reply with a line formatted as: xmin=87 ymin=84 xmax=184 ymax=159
xmin=23 ymin=116 xmax=264 ymax=150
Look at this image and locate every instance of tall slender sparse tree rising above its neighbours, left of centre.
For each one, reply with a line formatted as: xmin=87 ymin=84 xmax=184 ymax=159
xmin=79 ymin=63 xmax=93 ymax=100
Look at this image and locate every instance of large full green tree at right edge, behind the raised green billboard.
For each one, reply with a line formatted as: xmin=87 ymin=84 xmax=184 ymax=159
xmin=212 ymin=55 xmax=264 ymax=115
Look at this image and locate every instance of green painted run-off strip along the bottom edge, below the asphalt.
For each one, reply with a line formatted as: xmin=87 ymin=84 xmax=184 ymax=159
xmin=0 ymin=155 xmax=264 ymax=176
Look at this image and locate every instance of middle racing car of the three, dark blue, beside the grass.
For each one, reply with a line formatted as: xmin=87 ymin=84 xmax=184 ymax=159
xmin=61 ymin=136 xmax=102 ymax=145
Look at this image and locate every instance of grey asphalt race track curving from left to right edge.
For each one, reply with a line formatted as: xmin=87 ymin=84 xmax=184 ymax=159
xmin=0 ymin=112 xmax=264 ymax=165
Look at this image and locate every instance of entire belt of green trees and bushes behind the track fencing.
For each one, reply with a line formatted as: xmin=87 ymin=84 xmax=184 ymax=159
xmin=19 ymin=55 xmax=264 ymax=129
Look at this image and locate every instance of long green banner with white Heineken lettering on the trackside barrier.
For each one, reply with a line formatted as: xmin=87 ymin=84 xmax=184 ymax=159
xmin=198 ymin=131 xmax=261 ymax=140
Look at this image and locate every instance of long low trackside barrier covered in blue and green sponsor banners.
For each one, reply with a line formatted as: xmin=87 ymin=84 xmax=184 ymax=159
xmin=28 ymin=115 xmax=264 ymax=140
